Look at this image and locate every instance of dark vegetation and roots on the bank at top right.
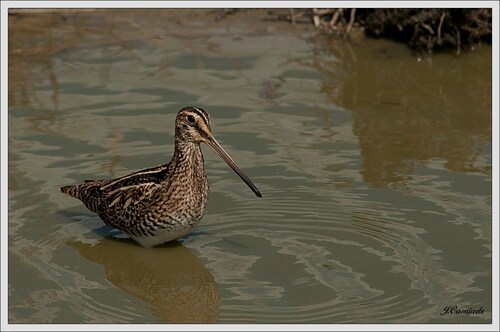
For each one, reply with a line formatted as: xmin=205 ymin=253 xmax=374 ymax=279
xmin=269 ymin=8 xmax=492 ymax=54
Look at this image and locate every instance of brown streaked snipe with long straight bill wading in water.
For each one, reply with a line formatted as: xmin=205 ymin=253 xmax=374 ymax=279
xmin=61 ymin=106 xmax=262 ymax=248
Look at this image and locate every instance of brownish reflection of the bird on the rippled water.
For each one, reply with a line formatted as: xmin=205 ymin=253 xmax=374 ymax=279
xmin=69 ymin=238 xmax=220 ymax=323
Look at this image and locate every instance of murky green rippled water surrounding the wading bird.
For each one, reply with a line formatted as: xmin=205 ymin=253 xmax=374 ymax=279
xmin=8 ymin=10 xmax=492 ymax=323
